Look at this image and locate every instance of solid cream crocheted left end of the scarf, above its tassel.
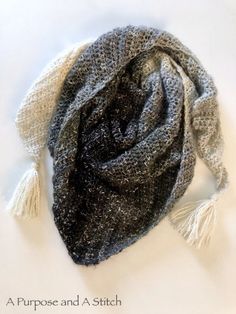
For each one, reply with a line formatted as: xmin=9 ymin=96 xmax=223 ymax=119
xmin=16 ymin=44 xmax=88 ymax=162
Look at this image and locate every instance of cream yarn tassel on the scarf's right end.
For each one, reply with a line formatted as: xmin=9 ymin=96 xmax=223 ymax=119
xmin=169 ymin=194 xmax=218 ymax=248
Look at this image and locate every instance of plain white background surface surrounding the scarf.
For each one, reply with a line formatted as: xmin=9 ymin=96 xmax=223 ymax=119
xmin=0 ymin=0 xmax=236 ymax=314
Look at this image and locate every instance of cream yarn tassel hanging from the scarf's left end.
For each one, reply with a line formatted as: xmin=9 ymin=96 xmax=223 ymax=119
xmin=7 ymin=163 xmax=40 ymax=218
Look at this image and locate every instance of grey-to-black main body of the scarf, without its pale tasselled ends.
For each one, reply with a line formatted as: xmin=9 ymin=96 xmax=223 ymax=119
xmin=48 ymin=26 xmax=214 ymax=265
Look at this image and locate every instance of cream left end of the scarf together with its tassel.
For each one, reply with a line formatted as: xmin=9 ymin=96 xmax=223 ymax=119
xmin=7 ymin=43 xmax=88 ymax=218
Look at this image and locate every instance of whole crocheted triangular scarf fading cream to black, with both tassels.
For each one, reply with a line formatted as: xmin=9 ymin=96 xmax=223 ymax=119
xmin=9 ymin=26 xmax=227 ymax=265
